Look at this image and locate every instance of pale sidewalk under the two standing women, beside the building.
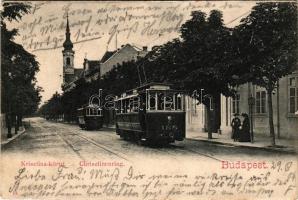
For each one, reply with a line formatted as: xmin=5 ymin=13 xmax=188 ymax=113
xmin=186 ymin=131 xmax=298 ymax=153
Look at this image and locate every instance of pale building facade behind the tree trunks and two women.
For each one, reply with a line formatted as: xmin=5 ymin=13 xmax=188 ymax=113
xmin=186 ymin=70 xmax=298 ymax=139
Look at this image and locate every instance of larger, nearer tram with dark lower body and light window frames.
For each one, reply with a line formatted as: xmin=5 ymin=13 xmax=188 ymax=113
xmin=115 ymin=83 xmax=185 ymax=144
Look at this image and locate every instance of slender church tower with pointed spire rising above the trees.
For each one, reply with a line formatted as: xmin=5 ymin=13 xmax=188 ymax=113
xmin=62 ymin=15 xmax=75 ymax=84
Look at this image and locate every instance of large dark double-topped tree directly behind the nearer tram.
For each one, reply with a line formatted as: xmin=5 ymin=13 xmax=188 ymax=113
xmin=146 ymin=10 xmax=239 ymax=139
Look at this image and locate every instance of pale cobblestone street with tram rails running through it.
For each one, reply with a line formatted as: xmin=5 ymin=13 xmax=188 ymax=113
xmin=2 ymin=118 xmax=290 ymax=162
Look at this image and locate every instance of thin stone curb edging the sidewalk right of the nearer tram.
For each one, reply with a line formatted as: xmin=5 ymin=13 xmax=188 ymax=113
xmin=186 ymin=138 xmax=298 ymax=154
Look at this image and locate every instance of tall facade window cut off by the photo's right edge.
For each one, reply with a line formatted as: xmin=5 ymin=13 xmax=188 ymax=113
xmin=289 ymin=77 xmax=298 ymax=114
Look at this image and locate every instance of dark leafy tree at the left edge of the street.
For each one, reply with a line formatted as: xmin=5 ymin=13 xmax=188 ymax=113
xmin=1 ymin=3 xmax=41 ymax=137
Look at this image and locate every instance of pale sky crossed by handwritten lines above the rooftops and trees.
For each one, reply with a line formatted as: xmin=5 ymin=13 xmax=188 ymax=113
xmin=8 ymin=1 xmax=255 ymax=102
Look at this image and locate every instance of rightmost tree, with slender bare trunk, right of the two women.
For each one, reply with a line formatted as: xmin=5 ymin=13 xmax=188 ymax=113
xmin=234 ymin=2 xmax=297 ymax=146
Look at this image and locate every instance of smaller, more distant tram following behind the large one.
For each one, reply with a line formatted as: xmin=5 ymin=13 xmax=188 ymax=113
xmin=77 ymin=105 xmax=103 ymax=130
